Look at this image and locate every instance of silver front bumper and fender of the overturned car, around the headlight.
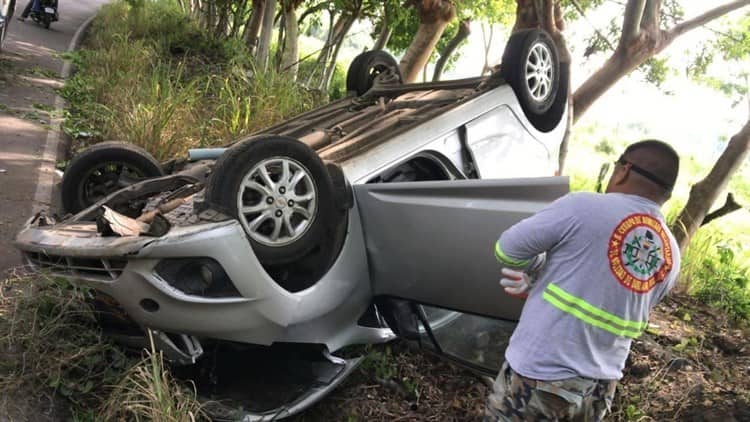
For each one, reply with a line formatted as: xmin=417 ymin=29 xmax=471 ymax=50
xmin=16 ymin=209 xmax=393 ymax=351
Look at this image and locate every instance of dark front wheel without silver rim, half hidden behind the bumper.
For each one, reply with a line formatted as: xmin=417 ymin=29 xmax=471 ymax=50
xmin=60 ymin=142 xmax=164 ymax=213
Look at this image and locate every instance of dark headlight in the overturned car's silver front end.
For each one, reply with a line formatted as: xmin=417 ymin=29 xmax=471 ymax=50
xmin=156 ymin=258 xmax=241 ymax=298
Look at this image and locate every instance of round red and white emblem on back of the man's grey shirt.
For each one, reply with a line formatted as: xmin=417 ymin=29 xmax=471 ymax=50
xmin=607 ymin=214 xmax=672 ymax=293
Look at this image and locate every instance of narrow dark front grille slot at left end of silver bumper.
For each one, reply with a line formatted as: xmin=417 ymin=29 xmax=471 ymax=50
xmin=26 ymin=252 xmax=128 ymax=281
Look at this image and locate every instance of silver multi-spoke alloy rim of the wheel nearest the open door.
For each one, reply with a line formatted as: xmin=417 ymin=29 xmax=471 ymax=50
xmin=237 ymin=157 xmax=318 ymax=247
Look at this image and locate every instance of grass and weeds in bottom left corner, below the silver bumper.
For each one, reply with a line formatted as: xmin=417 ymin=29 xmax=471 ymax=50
xmin=0 ymin=275 xmax=208 ymax=422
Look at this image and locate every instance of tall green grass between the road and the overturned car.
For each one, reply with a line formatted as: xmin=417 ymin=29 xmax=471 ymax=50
xmin=62 ymin=1 xmax=325 ymax=160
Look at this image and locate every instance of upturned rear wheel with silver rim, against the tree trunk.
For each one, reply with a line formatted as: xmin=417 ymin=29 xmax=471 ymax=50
xmin=500 ymin=29 xmax=567 ymax=130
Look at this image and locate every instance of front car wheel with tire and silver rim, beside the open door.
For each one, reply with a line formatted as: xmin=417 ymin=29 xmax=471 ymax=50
xmin=206 ymin=135 xmax=346 ymax=265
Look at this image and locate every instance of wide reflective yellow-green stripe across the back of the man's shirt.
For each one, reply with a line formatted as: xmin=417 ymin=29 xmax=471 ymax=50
xmin=542 ymin=283 xmax=648 ymax=338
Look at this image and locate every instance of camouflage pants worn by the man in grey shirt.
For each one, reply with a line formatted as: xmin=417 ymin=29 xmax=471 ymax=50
xmin=484 ymin=362 xmax=617 ymax=422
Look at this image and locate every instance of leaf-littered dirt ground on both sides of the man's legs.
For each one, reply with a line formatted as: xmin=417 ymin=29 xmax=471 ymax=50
xmin=294 ymin=295 xmax=750 ymax=422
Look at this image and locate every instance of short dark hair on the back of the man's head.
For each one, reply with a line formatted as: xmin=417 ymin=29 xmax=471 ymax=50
xmin=620 ymin=139 xmax=680 ymax=193
